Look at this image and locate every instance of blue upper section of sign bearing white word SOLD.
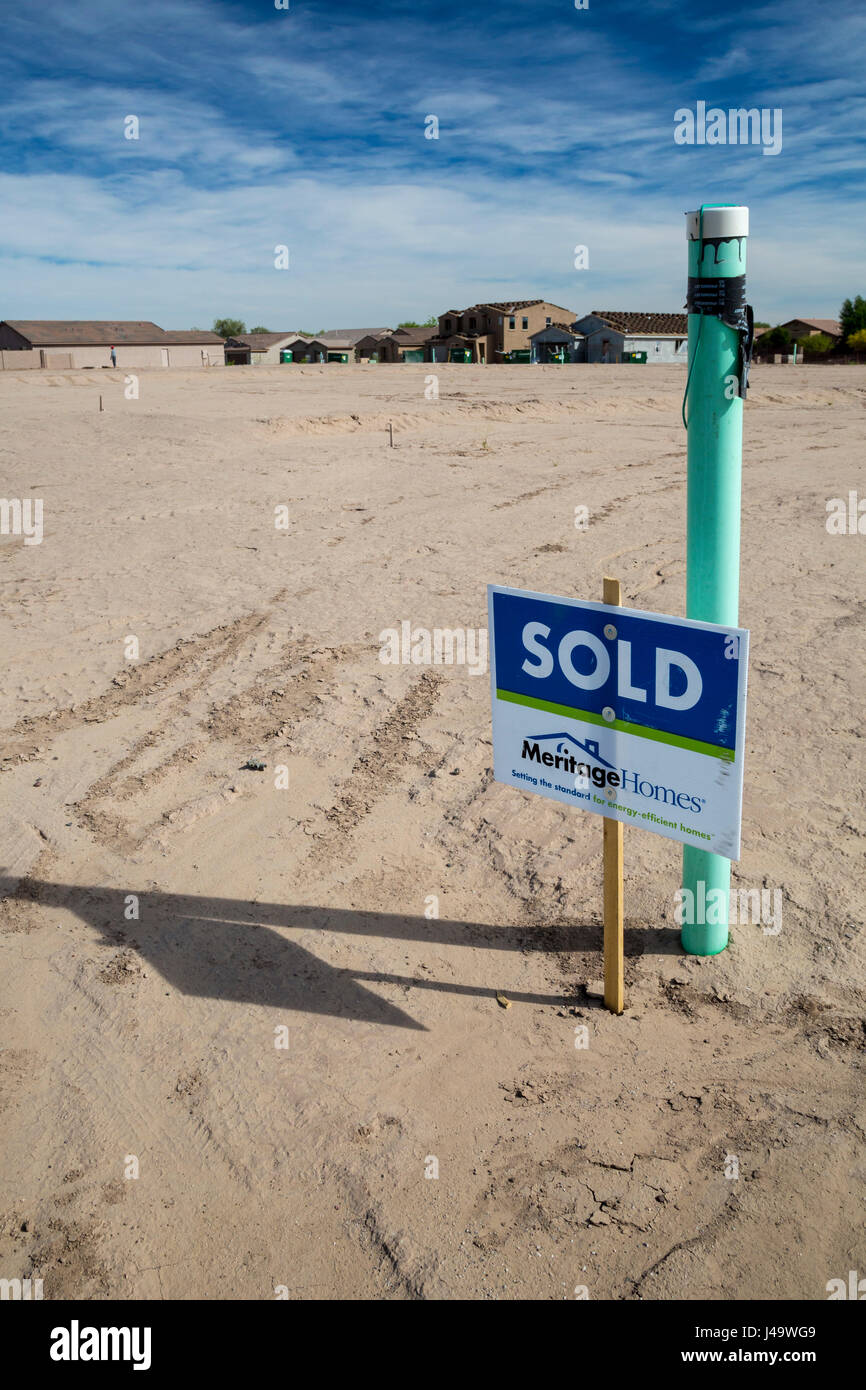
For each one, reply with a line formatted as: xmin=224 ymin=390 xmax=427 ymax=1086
xmin=492 ymin=589 xmax=740 ymax=749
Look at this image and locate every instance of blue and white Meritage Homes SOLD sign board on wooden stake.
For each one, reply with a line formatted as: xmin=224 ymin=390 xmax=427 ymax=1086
xmin=488 ymin=584 xmax=749 ymax=859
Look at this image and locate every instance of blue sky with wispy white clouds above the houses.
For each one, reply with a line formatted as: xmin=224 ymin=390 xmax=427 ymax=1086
xmin=0 ymin=0 xmax=866 ymax=329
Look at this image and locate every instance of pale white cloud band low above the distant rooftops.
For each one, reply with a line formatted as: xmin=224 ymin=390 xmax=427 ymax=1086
xmin=0 ymin=159 xmax=862 ymax=327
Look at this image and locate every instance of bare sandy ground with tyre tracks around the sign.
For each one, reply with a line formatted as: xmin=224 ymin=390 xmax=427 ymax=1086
xmin=0 ymin=367 xmax=866 ymax=1300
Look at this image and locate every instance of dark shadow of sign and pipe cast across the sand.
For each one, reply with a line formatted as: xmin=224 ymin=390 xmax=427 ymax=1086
xmin=0 ymin=877 xmax=680 ymax=1031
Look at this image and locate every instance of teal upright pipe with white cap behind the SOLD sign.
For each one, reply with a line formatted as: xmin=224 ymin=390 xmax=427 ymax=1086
xmin=681 ymin=203 xmax=749 ymax=955
